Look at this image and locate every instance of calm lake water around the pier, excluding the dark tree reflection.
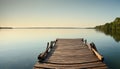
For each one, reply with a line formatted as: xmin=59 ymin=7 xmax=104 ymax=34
xmin=0 ymin=29 xmax=120 ymax=69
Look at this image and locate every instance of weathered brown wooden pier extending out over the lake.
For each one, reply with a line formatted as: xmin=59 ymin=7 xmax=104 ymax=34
xmin=33 ymin=38 xmax=108 ymax=69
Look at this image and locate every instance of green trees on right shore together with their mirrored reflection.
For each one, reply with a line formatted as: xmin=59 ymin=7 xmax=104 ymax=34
xmin=95 ymin=17 xmax=120 ymax=42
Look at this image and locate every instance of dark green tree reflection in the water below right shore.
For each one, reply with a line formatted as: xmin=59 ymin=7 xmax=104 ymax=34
xmin=96 ymin=29 xmax=120 ymax=42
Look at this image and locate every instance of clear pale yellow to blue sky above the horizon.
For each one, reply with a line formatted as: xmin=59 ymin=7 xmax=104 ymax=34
xmin=0 ymin=0 xmax=120 ymax=27
